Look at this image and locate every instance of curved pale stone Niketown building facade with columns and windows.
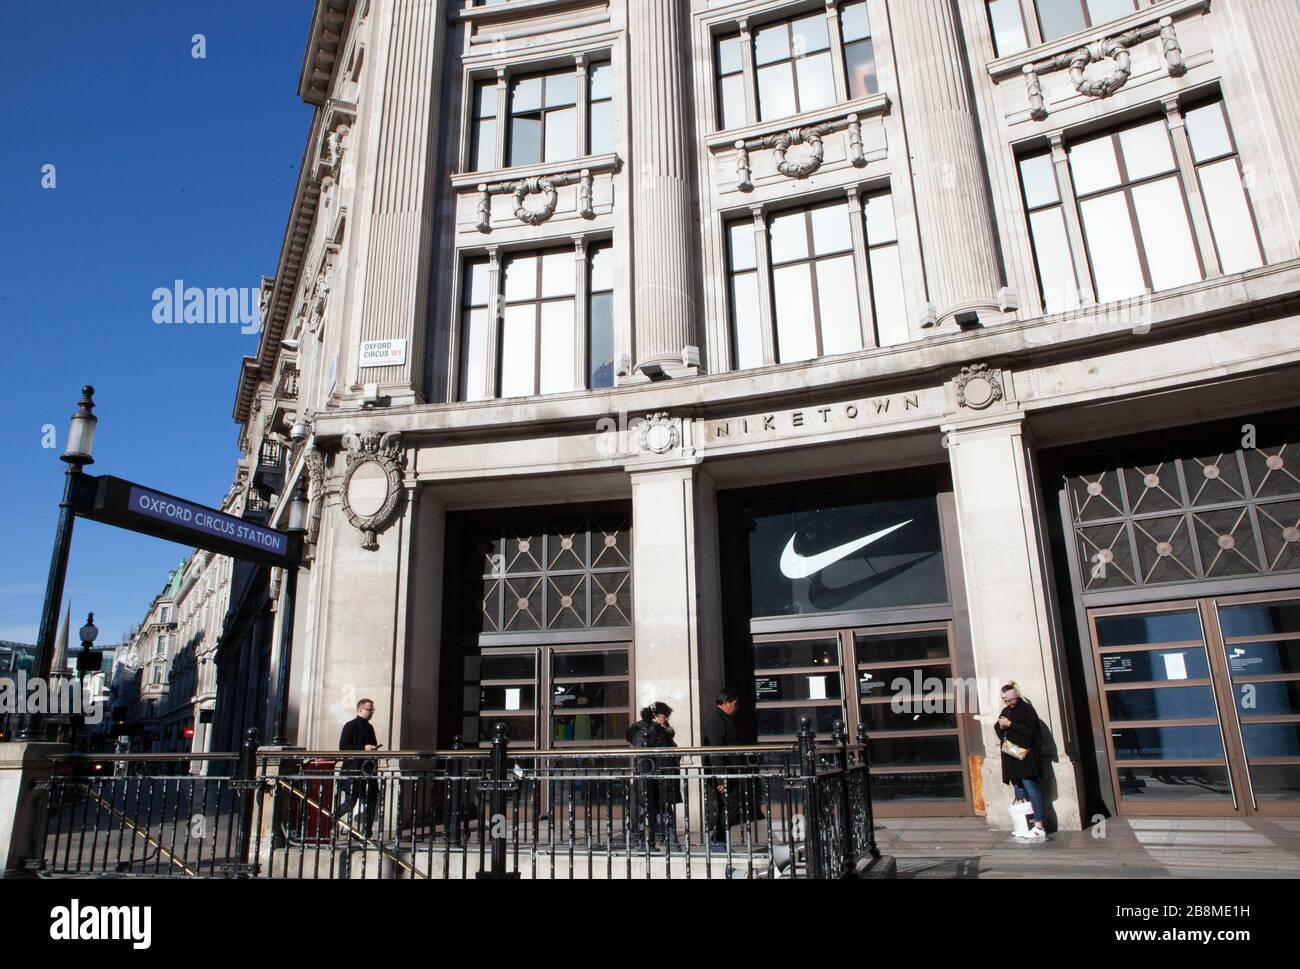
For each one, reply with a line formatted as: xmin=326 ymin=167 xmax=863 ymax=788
xmin=235 ymin=0 xmax=1300 ymax=829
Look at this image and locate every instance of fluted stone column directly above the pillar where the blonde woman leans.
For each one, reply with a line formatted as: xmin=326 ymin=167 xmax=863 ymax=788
xmin=889 ymin=0 xmax=1004 ymax=323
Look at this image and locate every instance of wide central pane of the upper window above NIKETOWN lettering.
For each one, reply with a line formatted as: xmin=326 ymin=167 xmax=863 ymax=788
xmin=754 ymin=10 xmax=837 ymax=121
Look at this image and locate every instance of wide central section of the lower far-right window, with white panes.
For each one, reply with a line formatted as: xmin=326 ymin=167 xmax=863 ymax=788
xmin=1070 ymin=118 xmax=1203 ymax=303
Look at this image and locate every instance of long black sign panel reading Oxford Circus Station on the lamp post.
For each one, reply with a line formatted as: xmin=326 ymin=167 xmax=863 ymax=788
xmin=75 ymin=475 xmax=302 ymax=567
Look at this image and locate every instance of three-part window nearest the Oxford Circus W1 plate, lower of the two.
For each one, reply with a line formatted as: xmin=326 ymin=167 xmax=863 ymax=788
xmin=459 ymin=243 xmax=615 ymax=401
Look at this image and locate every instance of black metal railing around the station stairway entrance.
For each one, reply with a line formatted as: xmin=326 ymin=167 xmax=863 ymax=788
xmin=38 ymin=721 xmax=879 ymax=879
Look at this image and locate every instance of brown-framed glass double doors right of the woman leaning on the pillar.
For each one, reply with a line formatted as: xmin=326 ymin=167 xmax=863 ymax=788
xmin=1089 ymin=596 xmax=1300 ymax=816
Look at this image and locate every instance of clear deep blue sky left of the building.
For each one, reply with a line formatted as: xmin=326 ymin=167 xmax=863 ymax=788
xmin=0 ymin=0 xmax=312 ymax=644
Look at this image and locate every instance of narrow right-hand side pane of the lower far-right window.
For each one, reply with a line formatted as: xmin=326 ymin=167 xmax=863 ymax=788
xmin=1184 ymin=101 xmax=1264 ymax=273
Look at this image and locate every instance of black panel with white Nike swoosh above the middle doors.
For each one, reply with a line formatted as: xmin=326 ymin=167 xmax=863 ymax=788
xmin=744 ymin=493 xmax=948 ymax=618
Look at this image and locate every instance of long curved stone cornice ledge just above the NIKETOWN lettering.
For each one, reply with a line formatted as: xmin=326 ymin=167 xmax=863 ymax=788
xmin=316 ymin=259 xmax=1300 ymax=446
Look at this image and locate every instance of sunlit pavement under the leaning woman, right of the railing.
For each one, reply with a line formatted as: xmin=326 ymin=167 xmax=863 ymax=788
xmin=876 ymin=818 xmax=1300 ymax=879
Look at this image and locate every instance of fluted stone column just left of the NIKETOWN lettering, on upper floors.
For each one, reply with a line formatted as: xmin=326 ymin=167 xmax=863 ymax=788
xmin=628 ymin=0 xmax=696 ymax=371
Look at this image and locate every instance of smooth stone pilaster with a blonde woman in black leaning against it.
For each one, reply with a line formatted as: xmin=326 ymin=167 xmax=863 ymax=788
xmin=944 ymin=414 xmax=1083 ymax=831
